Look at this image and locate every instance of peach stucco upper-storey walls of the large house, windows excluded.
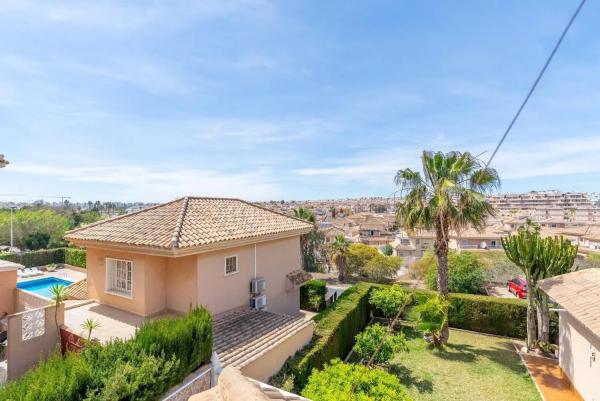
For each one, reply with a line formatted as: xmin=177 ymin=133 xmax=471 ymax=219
xmin=87 ymin=236 xmax=302 ymax=316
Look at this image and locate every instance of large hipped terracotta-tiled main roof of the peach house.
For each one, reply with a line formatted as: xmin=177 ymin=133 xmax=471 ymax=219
xmin=65 ymin=197 xmax=312 ymax=249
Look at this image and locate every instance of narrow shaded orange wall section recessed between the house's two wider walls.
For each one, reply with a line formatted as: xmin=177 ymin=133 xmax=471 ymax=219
xmin=166 ymin=255 xmax=198 ymax=313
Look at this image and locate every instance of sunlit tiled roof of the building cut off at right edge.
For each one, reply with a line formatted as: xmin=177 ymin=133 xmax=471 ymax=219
xmin=539 ymin=269 xmax=600 ymax=338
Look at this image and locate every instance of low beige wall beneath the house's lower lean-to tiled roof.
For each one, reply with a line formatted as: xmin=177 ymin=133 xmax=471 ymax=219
xmin=242 ymin=324 xmax=314 ymax=383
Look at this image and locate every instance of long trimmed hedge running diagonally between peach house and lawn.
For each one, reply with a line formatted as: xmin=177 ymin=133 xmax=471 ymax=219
xmin=278 ymin=283 xmax=375 ymax=392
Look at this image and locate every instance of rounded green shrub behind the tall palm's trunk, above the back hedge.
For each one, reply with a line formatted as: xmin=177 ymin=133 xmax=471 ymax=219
xmin=426 ymin=252 xmax=485 ymax=294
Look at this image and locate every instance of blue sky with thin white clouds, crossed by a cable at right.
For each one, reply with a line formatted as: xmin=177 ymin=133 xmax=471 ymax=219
xmin=0 ymin=0 xmax=600 ymax=201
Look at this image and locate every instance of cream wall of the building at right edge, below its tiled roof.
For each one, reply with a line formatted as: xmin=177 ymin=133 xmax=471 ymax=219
xmin=559 ymin=312 xmax=600 ymax=401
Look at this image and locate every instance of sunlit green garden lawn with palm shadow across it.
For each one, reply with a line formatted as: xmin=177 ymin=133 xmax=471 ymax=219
xmin=388 ymin=328 xmax=541 ymax=401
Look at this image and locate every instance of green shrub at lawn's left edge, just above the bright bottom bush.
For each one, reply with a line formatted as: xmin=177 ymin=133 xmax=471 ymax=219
xmin=352 ymin=323 xmax=407 ymax=364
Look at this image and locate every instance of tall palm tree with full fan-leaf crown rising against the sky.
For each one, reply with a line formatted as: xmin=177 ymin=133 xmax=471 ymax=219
xmin=394 ymin=151 xmax=500 ymax=342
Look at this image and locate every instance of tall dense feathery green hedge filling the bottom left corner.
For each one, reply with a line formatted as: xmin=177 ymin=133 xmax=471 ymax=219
xmin=0 ymin=308 xmax=213 ymax=401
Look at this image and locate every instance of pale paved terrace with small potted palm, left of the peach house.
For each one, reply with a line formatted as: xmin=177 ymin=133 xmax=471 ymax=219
xmin=65 ymin=302 xmax=177 ymax=343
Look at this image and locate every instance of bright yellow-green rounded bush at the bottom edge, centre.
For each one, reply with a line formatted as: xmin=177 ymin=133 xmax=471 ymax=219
xmin=302 ymin=360 xmax=412 ymax=401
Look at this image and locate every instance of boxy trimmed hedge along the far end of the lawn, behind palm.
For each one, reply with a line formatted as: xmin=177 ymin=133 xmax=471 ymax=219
xmin=405 ymin=290 xmax=558 ymax=340
